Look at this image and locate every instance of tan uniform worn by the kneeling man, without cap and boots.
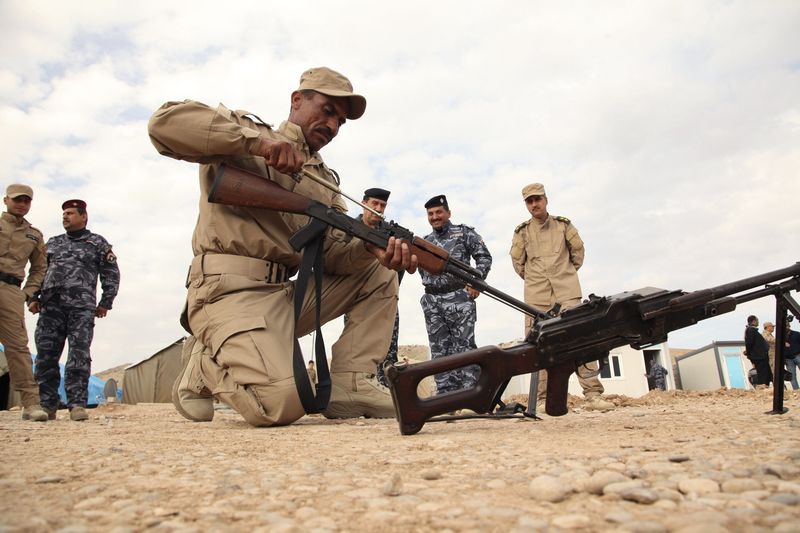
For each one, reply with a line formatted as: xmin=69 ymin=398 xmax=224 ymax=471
xmin=149 ymin=100 xmax=397 ymax=426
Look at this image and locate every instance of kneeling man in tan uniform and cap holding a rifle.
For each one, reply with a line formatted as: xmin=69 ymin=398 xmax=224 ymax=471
xmin=149 ymin=67 xmax=416 ymax=426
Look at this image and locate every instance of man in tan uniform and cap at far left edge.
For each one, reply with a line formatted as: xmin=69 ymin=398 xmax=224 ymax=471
xmin=0 ymin=184 xmax=47 ymax=422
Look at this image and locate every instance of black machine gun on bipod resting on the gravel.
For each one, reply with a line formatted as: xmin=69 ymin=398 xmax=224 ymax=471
xmin=386 ymin=263 xmax=800 ymax=435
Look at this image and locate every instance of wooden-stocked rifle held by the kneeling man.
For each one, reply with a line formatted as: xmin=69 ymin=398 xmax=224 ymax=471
xmin=208 ymin=165 xmax=551 ymax=319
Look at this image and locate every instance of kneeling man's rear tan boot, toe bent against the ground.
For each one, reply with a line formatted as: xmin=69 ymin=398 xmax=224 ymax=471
xmin=172 ymin=337 xmax=214 ymax=422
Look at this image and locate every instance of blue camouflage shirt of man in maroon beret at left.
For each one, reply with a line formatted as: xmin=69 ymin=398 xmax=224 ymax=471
xmin=40 ymin=229 xmax=119 ymax=309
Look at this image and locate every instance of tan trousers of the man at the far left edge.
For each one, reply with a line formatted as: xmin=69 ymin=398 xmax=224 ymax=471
xmin=0 ymin=281 xmax=39 ymax=407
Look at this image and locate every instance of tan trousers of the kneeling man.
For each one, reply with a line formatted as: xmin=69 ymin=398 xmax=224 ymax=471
xmin=188 ymin=255 xmax=398 ymax=426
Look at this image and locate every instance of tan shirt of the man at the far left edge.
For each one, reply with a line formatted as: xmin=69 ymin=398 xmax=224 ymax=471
xmin=0 ymin=211 xmax=47 ymax=299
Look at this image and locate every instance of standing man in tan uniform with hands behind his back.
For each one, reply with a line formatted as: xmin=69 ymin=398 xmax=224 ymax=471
xmin=511 ymin=183 xmax=614 ymax=410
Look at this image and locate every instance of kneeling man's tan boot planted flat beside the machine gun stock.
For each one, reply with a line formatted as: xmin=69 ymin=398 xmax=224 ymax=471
xmin=322 ymin=372 xmax=395 ymax=418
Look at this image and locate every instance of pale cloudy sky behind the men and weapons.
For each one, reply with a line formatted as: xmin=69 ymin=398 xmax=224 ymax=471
xmin=0 ymin=0 xmax=800 ymax=371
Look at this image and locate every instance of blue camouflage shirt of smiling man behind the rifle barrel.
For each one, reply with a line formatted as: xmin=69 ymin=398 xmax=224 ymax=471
xmin=419 ymin=221 xmax=492 ymax=288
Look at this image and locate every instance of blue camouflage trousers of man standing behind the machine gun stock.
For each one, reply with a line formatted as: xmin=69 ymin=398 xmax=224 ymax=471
xmin=420 ymin=289 xmax=480 ymax=394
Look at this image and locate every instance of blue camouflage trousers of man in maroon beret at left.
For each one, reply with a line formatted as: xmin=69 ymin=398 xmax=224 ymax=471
xmin=35 ymin=302 xmax=95 ymax=409
